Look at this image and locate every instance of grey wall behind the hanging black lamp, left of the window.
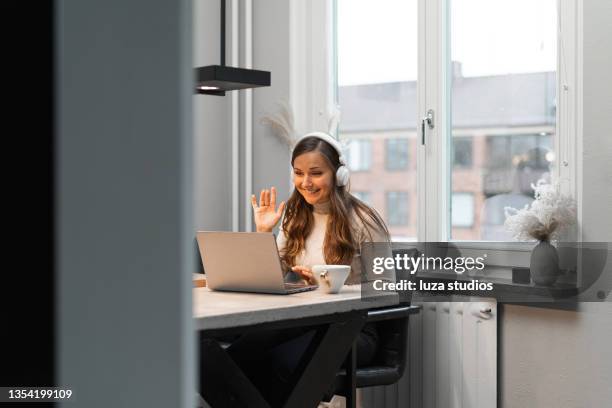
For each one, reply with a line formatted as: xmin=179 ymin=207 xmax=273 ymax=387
xmin=193 ymin=0 xmax=289 ymax=231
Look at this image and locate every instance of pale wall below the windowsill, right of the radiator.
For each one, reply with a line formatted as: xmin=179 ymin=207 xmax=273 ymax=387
xmin=499 ymin=303 xmax=612 ymax=408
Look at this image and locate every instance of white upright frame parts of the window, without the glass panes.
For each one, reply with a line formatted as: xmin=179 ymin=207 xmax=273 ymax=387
xmin=289 ymin=0 xmax=584 ymax=260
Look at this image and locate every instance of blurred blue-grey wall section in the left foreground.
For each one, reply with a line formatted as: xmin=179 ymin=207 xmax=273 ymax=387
xmin=55 ymin=0 xmax=195 ymax=408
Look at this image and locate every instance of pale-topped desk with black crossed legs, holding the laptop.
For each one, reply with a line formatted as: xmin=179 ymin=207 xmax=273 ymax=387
xmin=193 ymin=285 xmax=399 ymax=408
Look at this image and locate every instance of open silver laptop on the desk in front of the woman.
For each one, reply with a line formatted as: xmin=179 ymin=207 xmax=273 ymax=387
xmin=196 ymin=231 xmax=318 ymax=294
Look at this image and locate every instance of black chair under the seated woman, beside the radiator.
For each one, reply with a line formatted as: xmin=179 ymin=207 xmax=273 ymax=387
xmin=323 ymin=249 xmax=421 ymax=408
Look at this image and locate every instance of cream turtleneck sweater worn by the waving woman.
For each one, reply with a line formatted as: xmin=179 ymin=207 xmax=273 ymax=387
xmin=276 ymin=201 xmax=386 ymax=284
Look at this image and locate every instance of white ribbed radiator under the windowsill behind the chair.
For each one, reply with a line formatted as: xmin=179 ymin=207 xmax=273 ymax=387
xmin=358 ymin=297 xmax=497 ymax=408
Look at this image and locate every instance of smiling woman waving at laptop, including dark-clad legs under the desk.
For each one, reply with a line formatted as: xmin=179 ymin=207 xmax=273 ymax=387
xmin=230 ymin=132 xmax=389 ymax=399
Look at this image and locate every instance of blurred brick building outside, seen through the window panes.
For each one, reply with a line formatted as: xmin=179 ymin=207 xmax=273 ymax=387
xmin=338 ymin=70 xmax=556 ymax=241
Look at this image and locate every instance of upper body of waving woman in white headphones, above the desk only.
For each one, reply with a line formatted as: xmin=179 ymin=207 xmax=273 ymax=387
xmin=251 ymin=132 xmax=389 ymax=284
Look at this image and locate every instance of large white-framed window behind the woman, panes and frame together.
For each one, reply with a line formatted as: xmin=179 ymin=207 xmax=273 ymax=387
xmin=291 ymin=0 xmax=582 ymax=245
